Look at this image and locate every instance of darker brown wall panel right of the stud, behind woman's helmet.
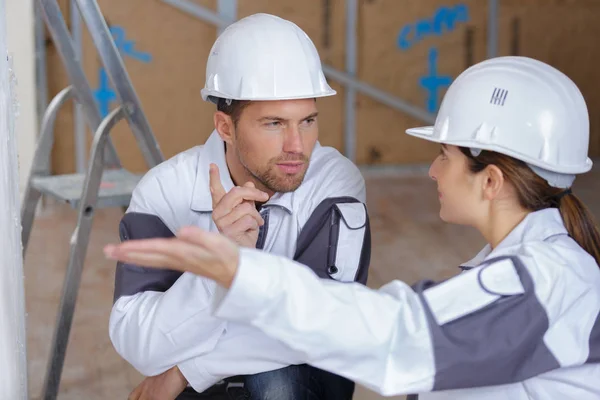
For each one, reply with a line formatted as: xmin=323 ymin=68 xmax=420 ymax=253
xmin=500 ymin=0 xmax=600 ymax=157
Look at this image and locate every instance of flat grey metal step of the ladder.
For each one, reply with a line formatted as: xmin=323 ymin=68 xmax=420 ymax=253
xmin=32 ymin=169 xmax=143 ymax=209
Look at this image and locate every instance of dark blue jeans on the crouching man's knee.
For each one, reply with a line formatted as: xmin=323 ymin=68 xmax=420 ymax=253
xmin=245 ymin=364 xmax=355 ymax=400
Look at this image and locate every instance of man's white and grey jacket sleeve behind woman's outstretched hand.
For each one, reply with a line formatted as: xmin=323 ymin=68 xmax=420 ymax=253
xmin=109 ymin=212 xmax=227 ymax=375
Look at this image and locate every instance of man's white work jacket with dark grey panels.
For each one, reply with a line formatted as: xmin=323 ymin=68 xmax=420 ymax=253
xmin=109 ymin=132 xmax=370 ymax=391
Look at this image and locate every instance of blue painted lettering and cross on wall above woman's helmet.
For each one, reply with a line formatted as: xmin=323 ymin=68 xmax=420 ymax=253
xmin=397 ymin=4 xmax=469 ymax=113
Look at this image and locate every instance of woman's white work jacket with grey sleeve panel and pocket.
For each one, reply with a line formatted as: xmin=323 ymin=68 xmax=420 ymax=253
xmin=213 ymin=208 xmax=600 ymax=400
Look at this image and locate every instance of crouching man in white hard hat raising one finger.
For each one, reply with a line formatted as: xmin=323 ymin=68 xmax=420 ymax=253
xmin=109 ymin=14 xmax=370 ymax=400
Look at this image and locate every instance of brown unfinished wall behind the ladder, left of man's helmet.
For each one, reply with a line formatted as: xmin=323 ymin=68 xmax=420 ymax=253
xmin=48 ymin=0 xmax=216 ymax=173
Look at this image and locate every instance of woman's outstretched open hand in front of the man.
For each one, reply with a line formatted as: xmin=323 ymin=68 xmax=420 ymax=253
xmin=104 ymin=227 xmax=239 ymax=288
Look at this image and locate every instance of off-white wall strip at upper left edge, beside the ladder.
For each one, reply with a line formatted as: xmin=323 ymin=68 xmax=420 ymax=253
xmin=4 ymin=0 xmax=39 ymax=199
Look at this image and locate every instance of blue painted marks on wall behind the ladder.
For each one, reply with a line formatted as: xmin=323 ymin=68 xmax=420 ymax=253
xmin=94 ymin=26 xmax=152 ymax=118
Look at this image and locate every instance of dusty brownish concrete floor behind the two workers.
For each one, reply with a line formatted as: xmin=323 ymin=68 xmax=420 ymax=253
xmin=25 ymin=172 xmax=600 ymax=400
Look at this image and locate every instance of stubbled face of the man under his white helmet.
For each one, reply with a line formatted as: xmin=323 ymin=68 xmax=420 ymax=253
xmin=231 ymin=99 xmax=319 ymax=192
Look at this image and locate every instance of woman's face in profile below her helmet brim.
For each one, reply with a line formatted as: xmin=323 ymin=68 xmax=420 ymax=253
xmin=429 ymin=145 xmax=484 ymax=226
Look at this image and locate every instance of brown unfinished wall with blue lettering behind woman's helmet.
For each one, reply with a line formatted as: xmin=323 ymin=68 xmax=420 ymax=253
xmin=357 ymin=0 xmax=600 ymax=164
